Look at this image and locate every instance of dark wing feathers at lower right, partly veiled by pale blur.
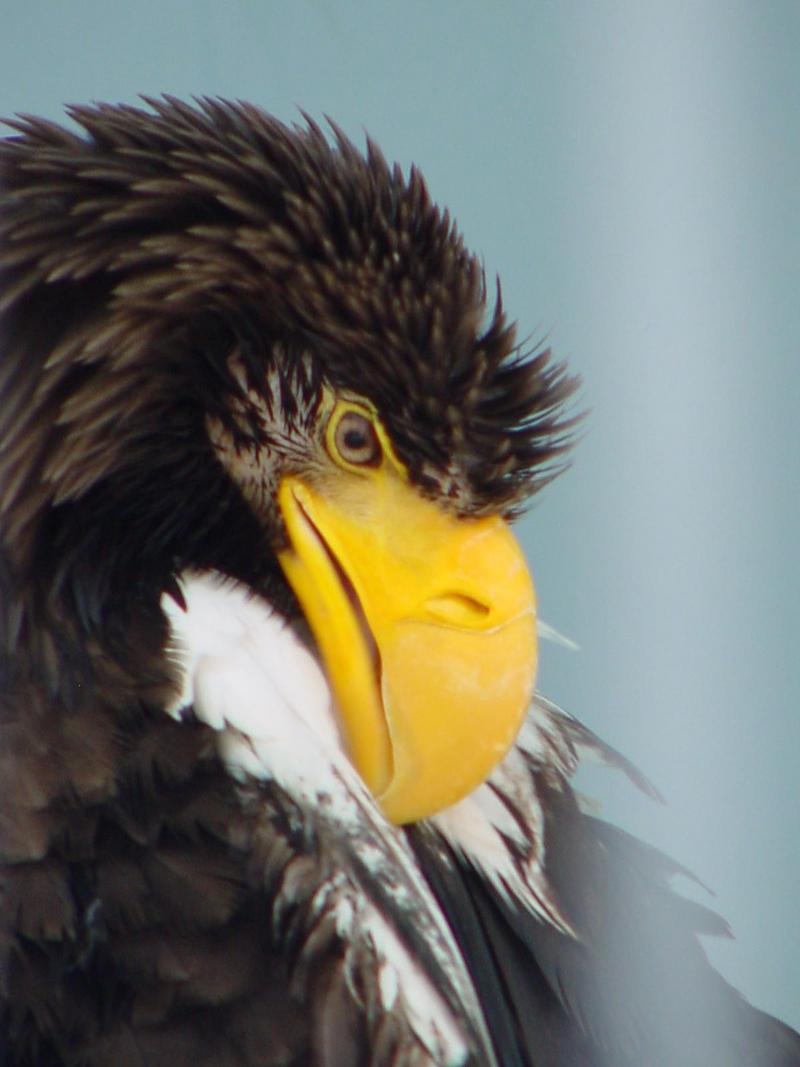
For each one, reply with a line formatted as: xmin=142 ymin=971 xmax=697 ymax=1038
xmin=411 ymin=781 xmax=800 ymax=1067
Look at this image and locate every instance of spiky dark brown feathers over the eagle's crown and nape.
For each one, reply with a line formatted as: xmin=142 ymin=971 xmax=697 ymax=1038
xmin=0 ymin=98 xmax=574 ymax=563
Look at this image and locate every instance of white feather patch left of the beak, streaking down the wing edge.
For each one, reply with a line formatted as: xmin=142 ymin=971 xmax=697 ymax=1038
xmin=161 ymin=573 xmax=482 ymax=1065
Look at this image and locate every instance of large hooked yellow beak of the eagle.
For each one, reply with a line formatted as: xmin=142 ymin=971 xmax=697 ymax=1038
xmin=278 ymin=469 xmax=537 ymax=823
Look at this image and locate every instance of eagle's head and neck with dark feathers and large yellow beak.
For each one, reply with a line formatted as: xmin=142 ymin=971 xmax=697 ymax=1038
xmin=0 ymin=93 xmax=575 ymax=823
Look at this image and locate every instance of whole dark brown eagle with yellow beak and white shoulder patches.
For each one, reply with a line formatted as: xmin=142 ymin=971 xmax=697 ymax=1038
xmin=0 ymin=97 xmax=800 ymax=1067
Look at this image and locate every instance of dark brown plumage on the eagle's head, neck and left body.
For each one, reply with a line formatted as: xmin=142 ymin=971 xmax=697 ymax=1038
xmin=0 ymin=98 xmax=798 ymax=1067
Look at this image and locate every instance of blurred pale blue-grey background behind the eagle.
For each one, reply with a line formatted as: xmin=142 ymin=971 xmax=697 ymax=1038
xmin=0 ymin=0 xmax=800 ymax=1026
